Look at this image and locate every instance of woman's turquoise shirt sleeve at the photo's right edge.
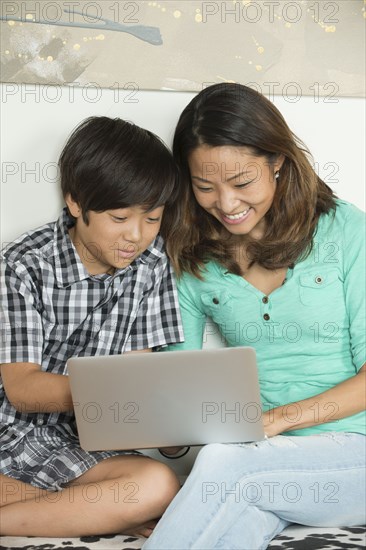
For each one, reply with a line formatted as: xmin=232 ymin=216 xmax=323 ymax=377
xmin=343 ymin=205 xmax=366 ymax=370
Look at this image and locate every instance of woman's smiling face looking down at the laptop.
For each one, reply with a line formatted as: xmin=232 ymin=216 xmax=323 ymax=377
xmin=188 ymin=145 xmax=284 ymax=239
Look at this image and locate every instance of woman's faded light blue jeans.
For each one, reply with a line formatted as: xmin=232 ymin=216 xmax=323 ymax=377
xmin=143 ymin=432 xmax=366 ymax=550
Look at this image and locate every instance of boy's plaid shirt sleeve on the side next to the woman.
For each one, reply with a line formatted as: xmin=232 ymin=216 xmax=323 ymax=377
xmin=126 ymin=258 xmax=183 ymax=351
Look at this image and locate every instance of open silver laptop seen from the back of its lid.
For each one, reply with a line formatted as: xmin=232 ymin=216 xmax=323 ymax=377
xmin=67 ymin=347 xmax=264 ymax=451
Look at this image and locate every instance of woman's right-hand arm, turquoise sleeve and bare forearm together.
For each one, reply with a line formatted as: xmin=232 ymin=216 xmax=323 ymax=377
xmin=263 ymin=205 xmax=366 ymax=436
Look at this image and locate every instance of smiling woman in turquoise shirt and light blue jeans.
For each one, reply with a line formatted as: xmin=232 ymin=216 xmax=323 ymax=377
xmin=144 ymin=84 xmax=366 ymax=550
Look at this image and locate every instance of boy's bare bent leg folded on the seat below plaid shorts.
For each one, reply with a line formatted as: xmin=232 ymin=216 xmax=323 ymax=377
xmin=0 ymin=455 xmax=179 ymax=537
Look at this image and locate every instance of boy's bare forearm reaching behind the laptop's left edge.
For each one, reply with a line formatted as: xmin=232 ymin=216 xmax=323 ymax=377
xmin=0 ymin=363 xmax=73 ymax=413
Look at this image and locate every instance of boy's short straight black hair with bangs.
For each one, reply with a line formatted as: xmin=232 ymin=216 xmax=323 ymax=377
xmin=59 ymin=116 xmax=177 ymax=223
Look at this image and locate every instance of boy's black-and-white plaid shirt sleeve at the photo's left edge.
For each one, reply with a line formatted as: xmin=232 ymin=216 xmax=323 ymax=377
xmin=0 ymin=261 xmax=43 ymax=365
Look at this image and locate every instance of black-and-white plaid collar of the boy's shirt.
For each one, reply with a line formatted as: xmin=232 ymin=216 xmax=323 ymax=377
xmin=53 ymin=208 xmax=165 ymax=287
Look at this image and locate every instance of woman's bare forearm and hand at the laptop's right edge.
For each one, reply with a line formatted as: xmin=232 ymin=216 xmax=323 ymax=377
xmin=263 ymin=364 xmax=366 ymax=437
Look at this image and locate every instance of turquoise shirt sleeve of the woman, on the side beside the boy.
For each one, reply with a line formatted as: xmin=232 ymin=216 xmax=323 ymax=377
xmin=168 ymin=275 xmax=206 ymax=351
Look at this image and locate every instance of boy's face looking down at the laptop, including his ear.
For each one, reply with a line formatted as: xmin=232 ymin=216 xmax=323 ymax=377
xmin=66 ymin=197 xmax=164 ymax=275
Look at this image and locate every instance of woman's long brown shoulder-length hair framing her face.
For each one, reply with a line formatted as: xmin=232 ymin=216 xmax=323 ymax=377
xmin=166 ymin=83 xmax=335 ymax=277
